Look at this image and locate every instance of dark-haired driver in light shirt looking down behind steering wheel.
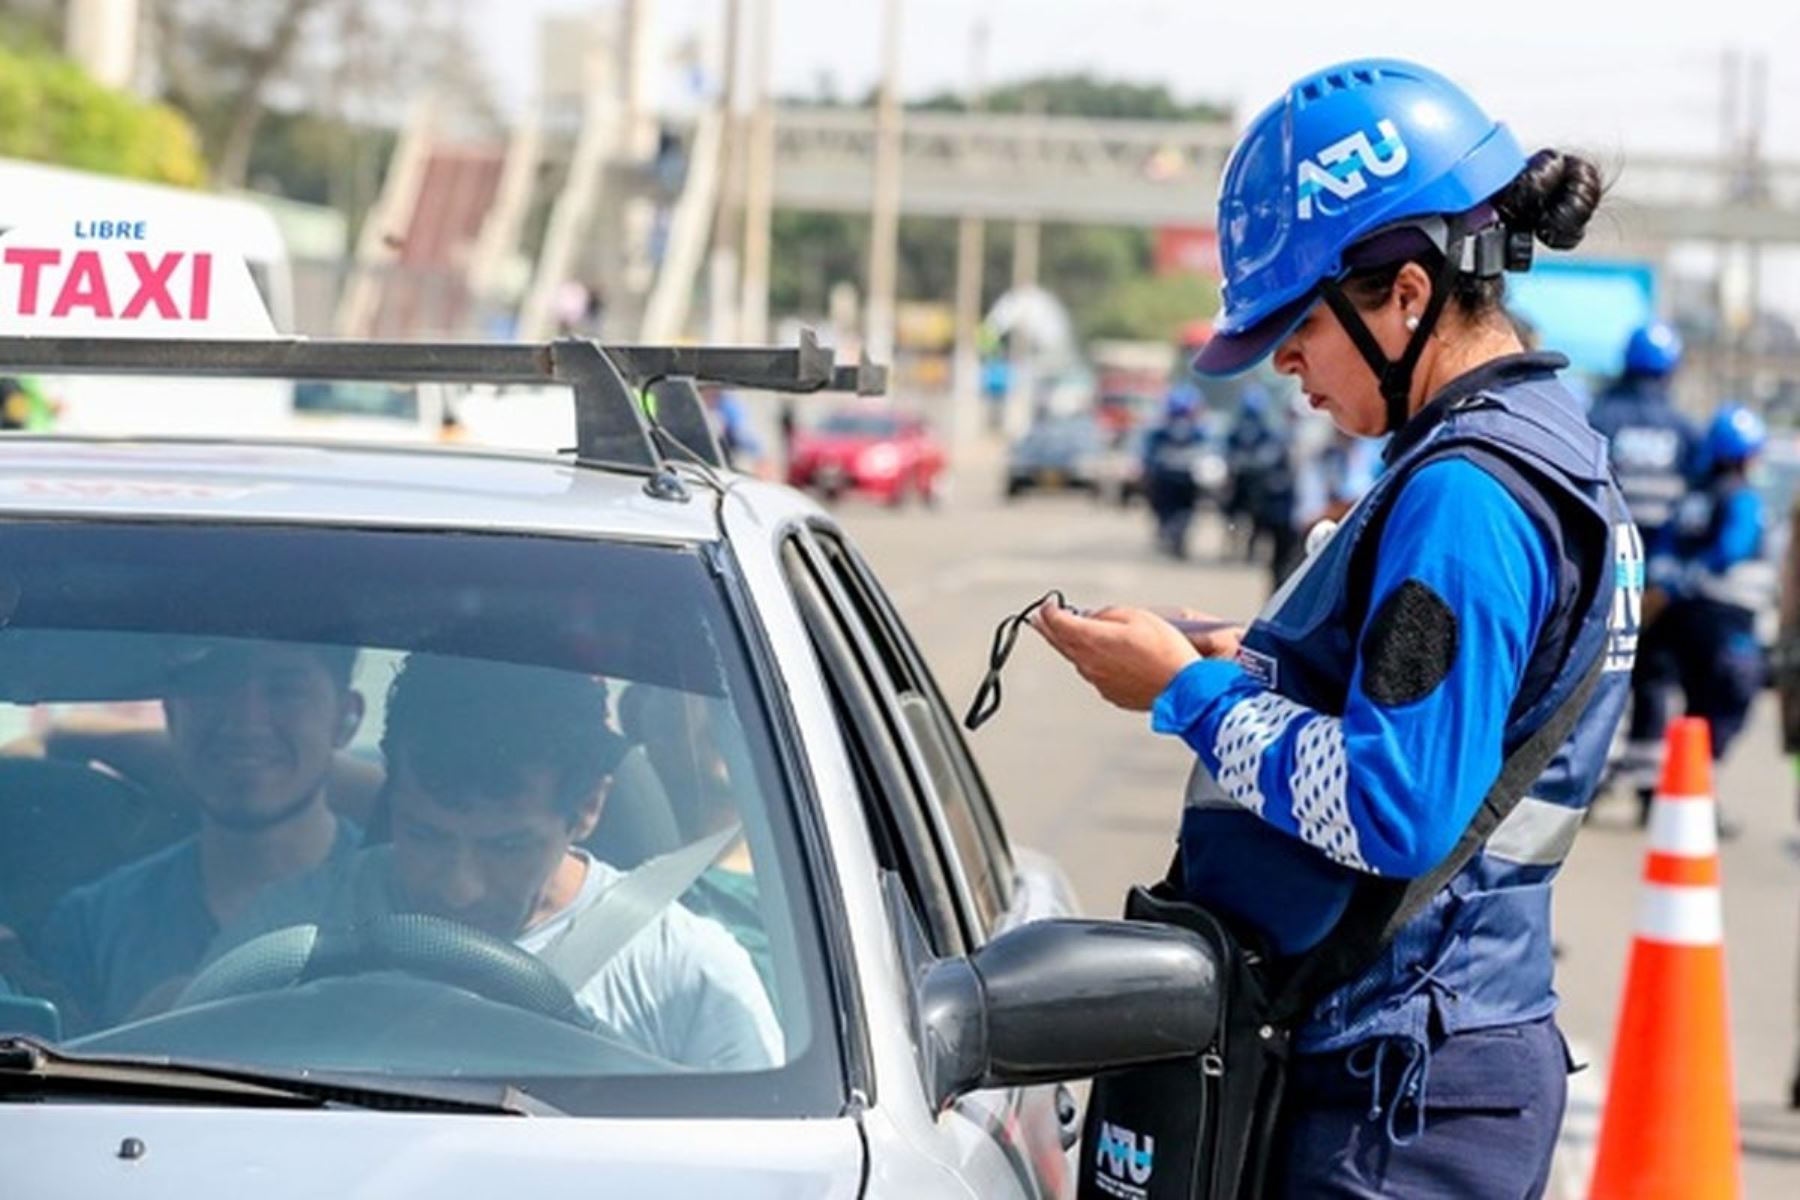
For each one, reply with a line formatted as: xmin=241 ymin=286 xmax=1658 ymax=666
xmin=218 ymin=653 xmax=781 ymax=1070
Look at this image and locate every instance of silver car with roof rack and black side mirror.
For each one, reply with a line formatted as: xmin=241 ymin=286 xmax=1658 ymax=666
xmin=0 ymin=227 xmax=1219 ymax=1200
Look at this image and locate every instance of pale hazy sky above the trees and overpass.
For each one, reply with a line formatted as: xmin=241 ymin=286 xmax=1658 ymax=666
xmin=464 ymin=0 xmax=1800 ymax=162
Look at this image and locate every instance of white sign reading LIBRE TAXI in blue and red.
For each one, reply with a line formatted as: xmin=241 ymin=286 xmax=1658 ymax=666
xmin=0 ymin=212 xmax=275 ymax=338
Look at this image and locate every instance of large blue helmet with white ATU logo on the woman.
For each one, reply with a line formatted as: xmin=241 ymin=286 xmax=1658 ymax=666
xmin=1193 ymin=58 xmax=1525 ymax=376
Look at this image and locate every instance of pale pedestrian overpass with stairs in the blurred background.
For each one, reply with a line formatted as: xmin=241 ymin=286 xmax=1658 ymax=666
xmin=344 ymin=97 xmax=1800 ymax=377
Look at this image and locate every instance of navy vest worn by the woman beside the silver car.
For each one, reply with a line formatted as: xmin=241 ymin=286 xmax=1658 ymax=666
xmin=1183 ymin=354 xmax=1643 ymax=1052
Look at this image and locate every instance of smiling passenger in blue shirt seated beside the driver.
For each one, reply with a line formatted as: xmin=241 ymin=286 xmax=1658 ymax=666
xmin=32 ymin=639 xmax=362 ymax=1029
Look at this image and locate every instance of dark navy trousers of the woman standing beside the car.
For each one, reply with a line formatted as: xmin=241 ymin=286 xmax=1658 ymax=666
xmin=1269 ymin=1016 xmax=1570 ymax=1200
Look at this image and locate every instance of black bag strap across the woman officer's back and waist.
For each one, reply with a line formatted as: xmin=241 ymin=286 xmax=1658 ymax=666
xmin=1269 ymin=655 xmax=1606 ymax=1022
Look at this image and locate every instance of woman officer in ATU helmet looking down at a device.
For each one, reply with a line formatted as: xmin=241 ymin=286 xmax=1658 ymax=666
xmin=1035 ymin=59 xmax=1642 ymax=1196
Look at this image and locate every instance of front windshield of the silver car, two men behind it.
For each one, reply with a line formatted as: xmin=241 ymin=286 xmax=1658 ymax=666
xmin=0 ymin=522 xmax=842 ymax=1115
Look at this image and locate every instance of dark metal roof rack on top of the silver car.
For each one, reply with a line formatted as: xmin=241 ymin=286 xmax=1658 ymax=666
xmin=0 ymin=329 xmax=886 ymax=489
